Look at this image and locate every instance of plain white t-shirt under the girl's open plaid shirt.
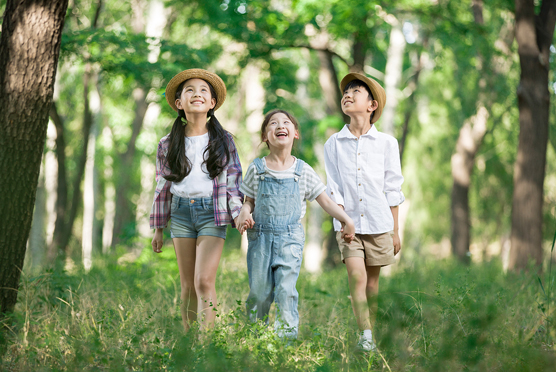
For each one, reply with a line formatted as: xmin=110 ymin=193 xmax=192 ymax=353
xmin=170 ymin=132 xmax=212 ymax=198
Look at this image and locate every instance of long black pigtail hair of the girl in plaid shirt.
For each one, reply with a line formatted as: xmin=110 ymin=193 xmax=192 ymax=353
xmin=164 ymin=80 xmax=230 ymax=182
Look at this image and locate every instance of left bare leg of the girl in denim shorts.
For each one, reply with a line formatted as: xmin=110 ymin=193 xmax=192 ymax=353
xmin=173 ymin=238 xmax=197 ymax=332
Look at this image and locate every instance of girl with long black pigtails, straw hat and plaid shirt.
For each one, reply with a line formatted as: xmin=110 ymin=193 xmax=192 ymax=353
xmin=150 ymin=69 xmax=243 ymax=331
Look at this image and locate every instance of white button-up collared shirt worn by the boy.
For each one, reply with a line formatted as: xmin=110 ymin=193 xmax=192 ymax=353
xmin=324 ymin=125 xmax=405 ymax=234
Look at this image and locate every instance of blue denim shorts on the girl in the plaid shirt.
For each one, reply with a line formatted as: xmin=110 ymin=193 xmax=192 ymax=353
xmin=170 ymin=195 xmax=227 ymax=239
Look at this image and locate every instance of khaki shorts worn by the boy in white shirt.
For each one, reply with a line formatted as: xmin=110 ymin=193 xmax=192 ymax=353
xmin=336 ymin=231 xmax=396 ymax=266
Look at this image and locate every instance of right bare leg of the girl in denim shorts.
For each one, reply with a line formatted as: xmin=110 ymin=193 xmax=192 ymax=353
xmin=195 ymin=236 xmax=224 ymax=329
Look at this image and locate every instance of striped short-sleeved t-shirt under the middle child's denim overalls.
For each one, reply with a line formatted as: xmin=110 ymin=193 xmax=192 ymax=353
xmin=239 ymin=158 xmax=326 ymax=219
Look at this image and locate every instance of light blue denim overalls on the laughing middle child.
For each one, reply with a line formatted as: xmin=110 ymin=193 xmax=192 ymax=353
xmin=246 ymin=158 xmax=305 ymax=338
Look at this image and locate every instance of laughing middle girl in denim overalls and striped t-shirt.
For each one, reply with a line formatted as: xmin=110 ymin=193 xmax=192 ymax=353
xmin=238 ymin=110 xmax=355 ymax=338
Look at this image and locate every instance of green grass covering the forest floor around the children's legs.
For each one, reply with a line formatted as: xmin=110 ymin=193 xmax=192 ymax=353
xmin=0 ymin=247 xmax=556 ymax=371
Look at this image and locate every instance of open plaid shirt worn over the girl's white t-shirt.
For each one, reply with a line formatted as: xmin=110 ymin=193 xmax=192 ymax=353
xmin=150 ymin=133 xmax=243 ymax=229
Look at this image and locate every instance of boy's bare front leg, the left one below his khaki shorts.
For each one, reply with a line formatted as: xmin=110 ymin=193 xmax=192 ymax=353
xmin=345 ymin=257 xmax=371 ymax=331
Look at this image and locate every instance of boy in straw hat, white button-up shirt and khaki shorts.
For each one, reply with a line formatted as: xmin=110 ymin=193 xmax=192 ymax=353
xmin=324 ymin=73 xmax=405 ymax=351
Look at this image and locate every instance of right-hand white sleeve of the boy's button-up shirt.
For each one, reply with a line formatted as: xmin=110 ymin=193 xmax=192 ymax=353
xmin=384 ymin=137 xmax=405 ymax=207
